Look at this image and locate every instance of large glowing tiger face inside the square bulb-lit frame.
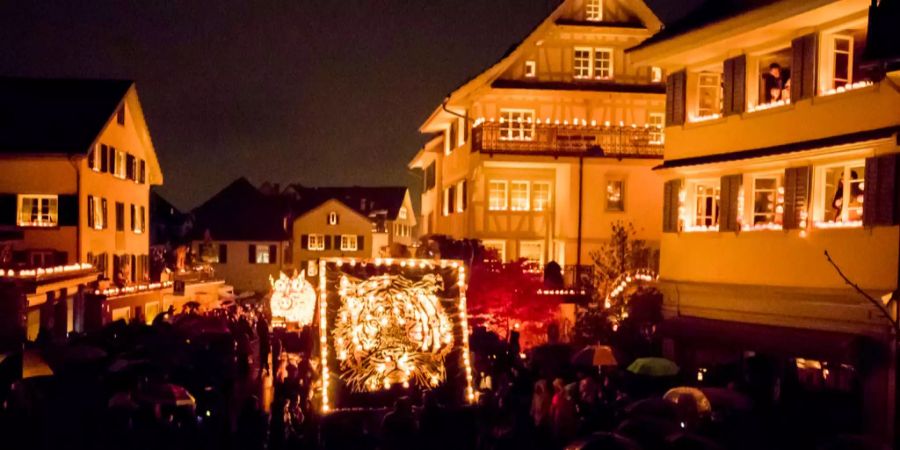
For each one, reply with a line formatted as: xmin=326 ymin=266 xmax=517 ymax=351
xmin=333 ymin=274 xmax=453 ymax=392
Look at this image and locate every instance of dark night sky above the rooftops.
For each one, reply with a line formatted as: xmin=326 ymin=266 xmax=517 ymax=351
xmin=0 ymin=0 xmax=696 ymax=208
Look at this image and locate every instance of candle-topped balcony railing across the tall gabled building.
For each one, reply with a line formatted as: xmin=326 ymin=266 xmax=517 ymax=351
xmin=472 ymin=122 xmax=663 ymax=158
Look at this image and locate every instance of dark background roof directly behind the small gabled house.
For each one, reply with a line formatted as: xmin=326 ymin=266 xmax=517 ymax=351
xmin=289 ymin=184 xmax=409 ymax=220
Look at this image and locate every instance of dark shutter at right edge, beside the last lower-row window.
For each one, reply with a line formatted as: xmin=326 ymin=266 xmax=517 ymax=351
xmin=863 ymin=154 xmax=900 ymax=227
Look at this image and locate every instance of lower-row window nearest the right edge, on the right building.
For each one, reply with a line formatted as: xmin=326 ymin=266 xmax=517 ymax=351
xmin=817 ymin=161 xmax=866 ymax=225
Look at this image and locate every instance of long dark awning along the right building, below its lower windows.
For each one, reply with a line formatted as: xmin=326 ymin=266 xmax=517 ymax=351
xmin=658 ymin=317 xmax=874 ymax=365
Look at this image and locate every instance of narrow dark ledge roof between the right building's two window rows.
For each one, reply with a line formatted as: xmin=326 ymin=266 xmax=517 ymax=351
xmin=654 ymin=126 xmax=900 ymax=170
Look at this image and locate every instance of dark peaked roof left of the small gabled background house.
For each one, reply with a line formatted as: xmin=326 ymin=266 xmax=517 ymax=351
xmin=191 ymin=177 xmax=290 ymax=241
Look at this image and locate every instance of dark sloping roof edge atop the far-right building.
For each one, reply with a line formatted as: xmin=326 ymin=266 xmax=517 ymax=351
xmin=628 ymin=0 xmax=780 ymax=52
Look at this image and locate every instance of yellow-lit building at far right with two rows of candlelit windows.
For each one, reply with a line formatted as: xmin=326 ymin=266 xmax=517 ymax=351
xmin=628 ymin=0 xmax=900 ymax=439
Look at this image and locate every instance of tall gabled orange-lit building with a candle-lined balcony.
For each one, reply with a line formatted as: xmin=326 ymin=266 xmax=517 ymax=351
xmin=409 ymin=0 xmax=665 ymax=278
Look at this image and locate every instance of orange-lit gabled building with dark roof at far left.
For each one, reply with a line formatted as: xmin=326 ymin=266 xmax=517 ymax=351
xmin=0 ymin=78 xmax=163 ymax=338
